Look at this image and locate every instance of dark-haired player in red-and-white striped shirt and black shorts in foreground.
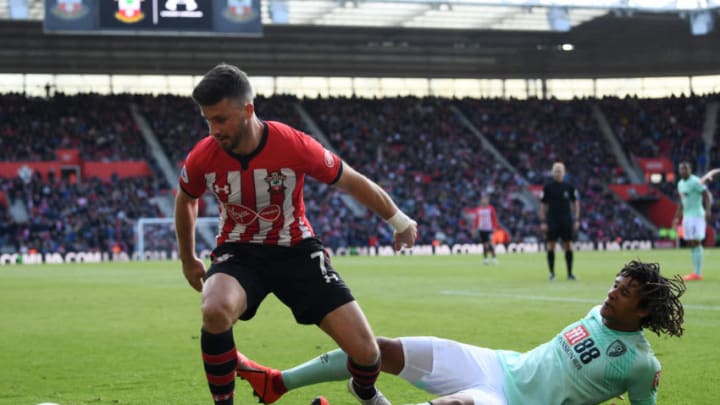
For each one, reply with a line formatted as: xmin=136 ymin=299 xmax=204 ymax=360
xmin=175 ymin=64 xmax=417 ymax=405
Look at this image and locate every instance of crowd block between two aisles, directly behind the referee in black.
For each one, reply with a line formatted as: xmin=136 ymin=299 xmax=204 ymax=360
xmin=462 ymin=99 xmax=654 ymax=241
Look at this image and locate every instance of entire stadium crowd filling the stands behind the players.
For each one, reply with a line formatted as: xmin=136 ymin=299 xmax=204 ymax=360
xmin=0 ymin=94 xmax=720 ymax=252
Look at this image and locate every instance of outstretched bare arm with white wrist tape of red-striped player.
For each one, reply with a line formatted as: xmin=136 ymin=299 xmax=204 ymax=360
xmin=335 ymin=162 xmax=417 ymax=250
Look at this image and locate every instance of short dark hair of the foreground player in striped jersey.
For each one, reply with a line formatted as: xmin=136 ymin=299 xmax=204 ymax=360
xmin=192 ymin=63 xmax=252 ymax=106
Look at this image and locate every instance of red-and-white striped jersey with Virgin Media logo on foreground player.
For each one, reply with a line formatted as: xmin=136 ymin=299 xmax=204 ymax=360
xmin=180 ymin=121 xmax=342 ymax=246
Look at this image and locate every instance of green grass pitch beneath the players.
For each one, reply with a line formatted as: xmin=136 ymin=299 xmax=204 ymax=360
xmin=0 ymin=250 xmax=720 ymax=405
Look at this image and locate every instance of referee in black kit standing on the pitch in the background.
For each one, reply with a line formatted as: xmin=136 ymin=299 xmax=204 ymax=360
xmin=540 ymin=162 xmax=580 ymax=281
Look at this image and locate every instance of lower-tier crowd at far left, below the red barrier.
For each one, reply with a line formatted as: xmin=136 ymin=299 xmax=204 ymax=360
xmin=0 ymin=173 xmax=162 ymax=253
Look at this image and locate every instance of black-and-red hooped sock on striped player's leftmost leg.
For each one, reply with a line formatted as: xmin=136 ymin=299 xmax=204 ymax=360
xmin=200 ymin=328 xmax=237 ymax=405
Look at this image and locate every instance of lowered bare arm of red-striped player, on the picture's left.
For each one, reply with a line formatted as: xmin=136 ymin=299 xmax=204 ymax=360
xmin=175 ymin=188 xmax=205 ymax=291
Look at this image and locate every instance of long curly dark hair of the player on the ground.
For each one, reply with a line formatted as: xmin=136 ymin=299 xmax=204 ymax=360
xmin=618 ymin=260 xmax=685 ymax=336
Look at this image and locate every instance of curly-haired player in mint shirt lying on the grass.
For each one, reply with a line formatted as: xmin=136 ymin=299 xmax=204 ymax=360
xmin=233 ymin=261 xmax=685 ymax=405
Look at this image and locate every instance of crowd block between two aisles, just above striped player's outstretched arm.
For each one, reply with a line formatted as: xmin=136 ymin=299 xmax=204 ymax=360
xmin=303 ymin=97 xmax=533 ymax=246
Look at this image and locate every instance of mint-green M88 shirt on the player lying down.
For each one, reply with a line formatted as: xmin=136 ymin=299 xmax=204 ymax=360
xmin=497 ymin=306 xmax=660 ymax=405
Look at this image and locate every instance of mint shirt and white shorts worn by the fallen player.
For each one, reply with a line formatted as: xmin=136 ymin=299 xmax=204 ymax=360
xmin=400 ymin=306 xmax=660 ymax=405
